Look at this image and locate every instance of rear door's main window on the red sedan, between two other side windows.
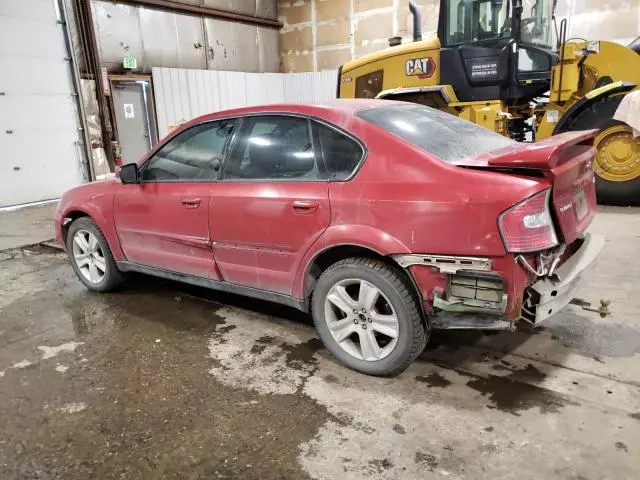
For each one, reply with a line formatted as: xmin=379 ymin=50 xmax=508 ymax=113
xmin=223 ymin=115 xmax=318 ymax=180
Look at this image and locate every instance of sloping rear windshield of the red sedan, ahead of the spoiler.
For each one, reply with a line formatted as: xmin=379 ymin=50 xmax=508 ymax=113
xmin=356 ymin=104 xmax=515 ymax=163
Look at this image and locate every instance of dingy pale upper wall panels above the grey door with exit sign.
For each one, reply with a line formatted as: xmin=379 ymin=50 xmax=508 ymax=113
xmin=93 ymin=0 xmax=280 ymax=72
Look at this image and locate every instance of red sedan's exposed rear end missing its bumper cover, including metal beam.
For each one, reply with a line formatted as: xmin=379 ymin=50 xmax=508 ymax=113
xmin=394 ymin=234 xmax=604 ymax=330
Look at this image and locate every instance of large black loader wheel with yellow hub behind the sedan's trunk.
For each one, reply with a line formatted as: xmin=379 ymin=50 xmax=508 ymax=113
xmin=565 ymin=96 xmax=640 ymax=205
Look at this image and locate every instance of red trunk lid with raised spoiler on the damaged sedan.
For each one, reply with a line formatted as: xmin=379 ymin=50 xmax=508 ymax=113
xmin=454 ymin=130 xmax=597 ymax=244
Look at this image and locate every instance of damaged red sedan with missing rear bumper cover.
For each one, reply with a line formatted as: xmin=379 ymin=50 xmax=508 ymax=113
xmin=55 ymin=100 xmax=604 ymax=375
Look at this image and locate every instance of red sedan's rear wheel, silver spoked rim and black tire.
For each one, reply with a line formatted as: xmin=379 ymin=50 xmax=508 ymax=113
xmin=311 ymin=258 xmax=429 ymax=377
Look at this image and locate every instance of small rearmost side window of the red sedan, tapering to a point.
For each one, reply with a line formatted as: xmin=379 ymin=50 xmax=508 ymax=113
xmin=313 ymin=122 xmax=364 ymax=180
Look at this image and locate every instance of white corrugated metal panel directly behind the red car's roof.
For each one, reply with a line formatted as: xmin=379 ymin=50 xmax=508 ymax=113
xmin=153 ymin=68 xmax=337 ymax=137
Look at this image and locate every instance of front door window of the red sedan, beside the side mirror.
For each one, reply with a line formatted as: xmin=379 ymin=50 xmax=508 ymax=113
xmin=141 ymin=120 xmax=235 ymax=182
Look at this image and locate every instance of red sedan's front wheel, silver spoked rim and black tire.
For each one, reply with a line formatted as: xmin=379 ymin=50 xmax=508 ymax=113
xmin=66 ymin=217 xmax=124 ymax=292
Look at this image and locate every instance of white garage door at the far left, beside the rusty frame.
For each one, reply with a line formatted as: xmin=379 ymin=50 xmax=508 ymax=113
xmin=0 ymin=0 xmax=83 ymax=207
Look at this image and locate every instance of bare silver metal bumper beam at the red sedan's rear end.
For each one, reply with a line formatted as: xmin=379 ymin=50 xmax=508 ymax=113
xmin=521 ymin=234 xmax=605 ymax=325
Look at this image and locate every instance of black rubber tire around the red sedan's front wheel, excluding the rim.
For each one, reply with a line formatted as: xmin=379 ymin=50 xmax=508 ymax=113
xmin=66 ymin=217 xmax=124 ymax=292
